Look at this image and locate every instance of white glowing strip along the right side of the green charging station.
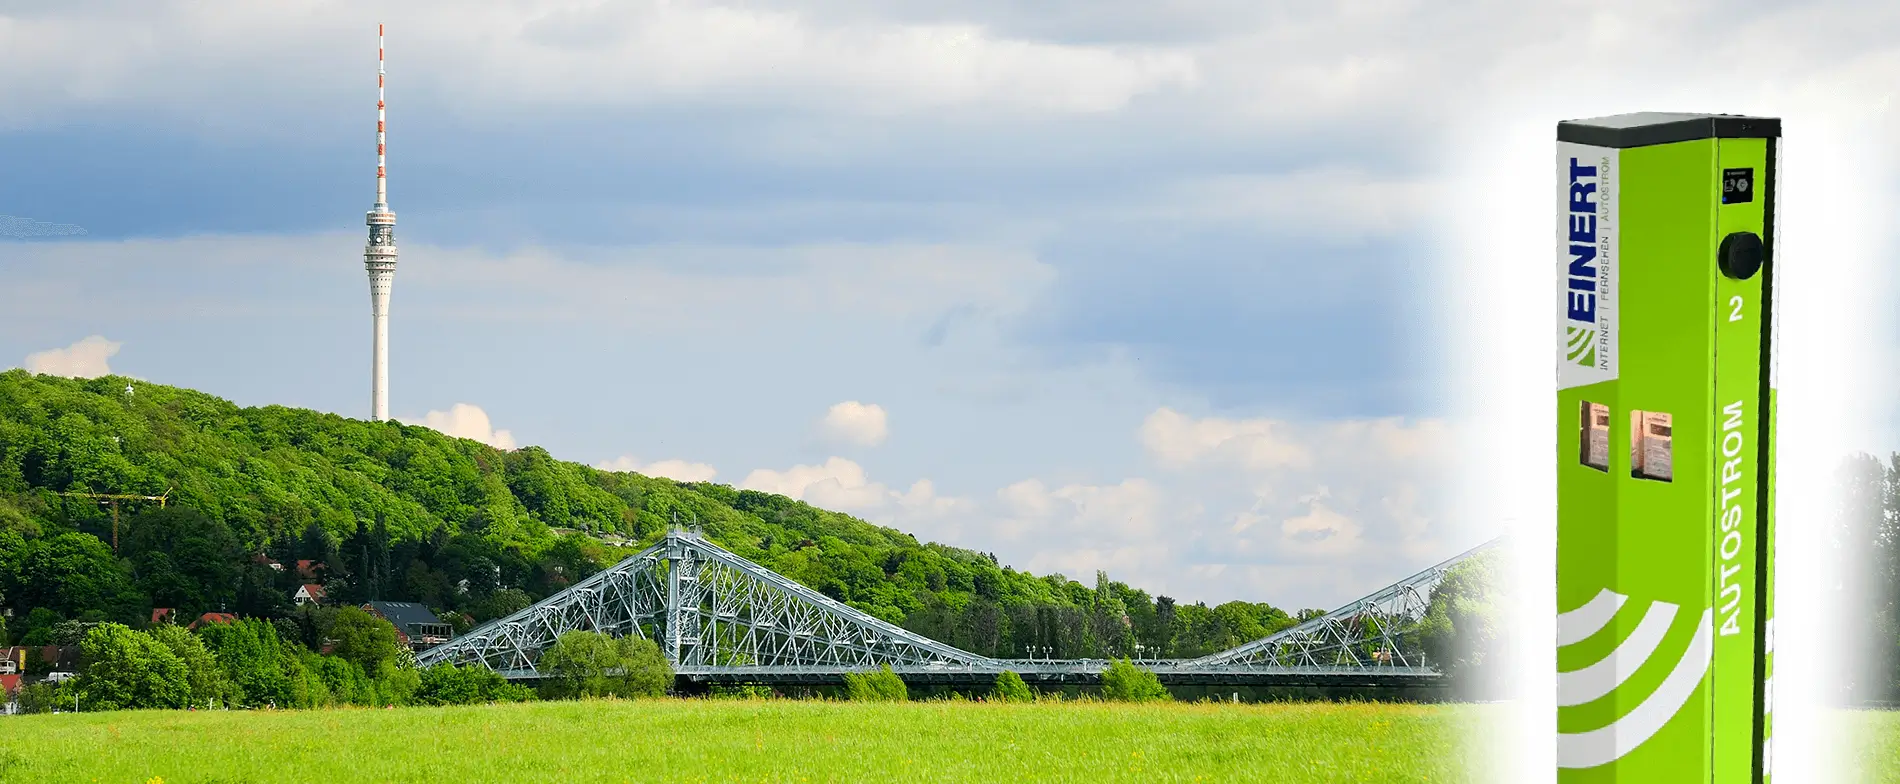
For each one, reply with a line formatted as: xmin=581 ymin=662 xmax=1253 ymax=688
xmin=1771 ymin=106 xmax=1900 ymax=782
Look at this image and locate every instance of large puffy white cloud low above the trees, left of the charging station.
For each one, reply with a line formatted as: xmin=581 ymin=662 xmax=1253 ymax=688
xmin=851 ymin=408 xmax=1466 ymax=609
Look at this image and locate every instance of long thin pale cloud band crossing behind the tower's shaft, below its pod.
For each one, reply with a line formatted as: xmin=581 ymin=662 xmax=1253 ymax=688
xmin=0 ymin=232 xmax=1055 ymax=334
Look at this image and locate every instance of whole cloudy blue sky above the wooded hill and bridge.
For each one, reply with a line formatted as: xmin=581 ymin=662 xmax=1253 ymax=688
xmin=0 ymin=0 xmax=1900 ymax=607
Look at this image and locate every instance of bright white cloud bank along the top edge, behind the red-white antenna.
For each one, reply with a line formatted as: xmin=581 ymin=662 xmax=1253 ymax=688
xmin=0 ymin=0 xmax=1197 ymax=130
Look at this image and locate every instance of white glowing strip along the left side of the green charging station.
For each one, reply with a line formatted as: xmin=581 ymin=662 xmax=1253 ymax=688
xmin=1433 ymin=112 xmax=1569 ymax=784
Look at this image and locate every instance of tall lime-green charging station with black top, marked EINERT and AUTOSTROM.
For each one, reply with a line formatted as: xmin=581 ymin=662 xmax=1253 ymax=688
xmin=1556 ymin=112 xmax=1780 ymax=784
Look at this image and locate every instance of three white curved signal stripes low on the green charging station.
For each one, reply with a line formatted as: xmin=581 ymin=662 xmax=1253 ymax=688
xmin=1556 ymin=588 xmax=1714 ymax=767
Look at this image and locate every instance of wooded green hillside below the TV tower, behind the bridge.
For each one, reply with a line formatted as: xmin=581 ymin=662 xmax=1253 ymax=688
xmin=0 ymin=370 xmax=1352 ymax=659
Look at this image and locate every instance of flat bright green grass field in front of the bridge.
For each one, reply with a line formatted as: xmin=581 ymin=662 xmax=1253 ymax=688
xmin=0 ymin=700 xmax=1486 ymax=784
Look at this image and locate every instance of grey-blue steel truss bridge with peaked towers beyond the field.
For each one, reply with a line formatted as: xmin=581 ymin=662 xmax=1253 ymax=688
xmin=416 ymin=532 xmax=1497 ymax=687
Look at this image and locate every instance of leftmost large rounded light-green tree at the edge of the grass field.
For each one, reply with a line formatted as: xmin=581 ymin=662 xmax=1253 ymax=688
xmin=74 ymin=623 xmax=192 ymax=710
